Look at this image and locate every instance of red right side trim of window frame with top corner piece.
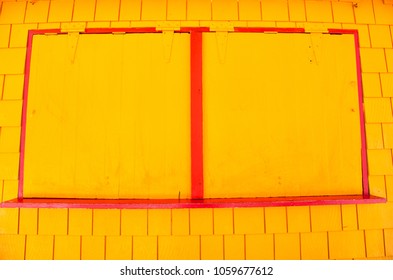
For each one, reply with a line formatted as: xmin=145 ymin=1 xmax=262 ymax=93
xmin=329 ymin=29 xmax=370 ymax=196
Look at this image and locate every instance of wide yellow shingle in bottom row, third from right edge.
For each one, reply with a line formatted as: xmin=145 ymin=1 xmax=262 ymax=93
xmin=328 ymin=231 xmax=366 ymax=259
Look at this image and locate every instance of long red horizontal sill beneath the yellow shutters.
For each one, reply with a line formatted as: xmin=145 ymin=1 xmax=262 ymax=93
xmin=0 ymin=195 xmax=386 ymax=209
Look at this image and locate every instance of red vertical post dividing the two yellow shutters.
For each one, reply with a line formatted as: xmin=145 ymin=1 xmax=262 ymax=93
xmin=190 ymin=31 xmax=203 ymax=199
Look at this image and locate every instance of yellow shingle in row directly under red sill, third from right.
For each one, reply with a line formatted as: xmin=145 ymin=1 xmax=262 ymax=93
xmin=310 ymin=205 xmax=342 ymax=232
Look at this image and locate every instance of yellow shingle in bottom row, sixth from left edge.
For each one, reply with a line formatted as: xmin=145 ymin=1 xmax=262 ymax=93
xmin=132 ymin=236 xmax=157 ymax=260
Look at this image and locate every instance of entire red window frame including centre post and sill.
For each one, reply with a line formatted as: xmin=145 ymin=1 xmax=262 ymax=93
xmin=1 ymin=28 xmax=386 ymax=209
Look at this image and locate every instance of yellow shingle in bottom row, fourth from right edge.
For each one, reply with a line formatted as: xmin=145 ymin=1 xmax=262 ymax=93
xmin=300 ymin=232 xmax=329 ymax=260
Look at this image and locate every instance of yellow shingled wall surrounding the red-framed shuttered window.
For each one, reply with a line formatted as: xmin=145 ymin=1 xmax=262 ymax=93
xmin=0 ymin=0 xmax=393 ymax=259
